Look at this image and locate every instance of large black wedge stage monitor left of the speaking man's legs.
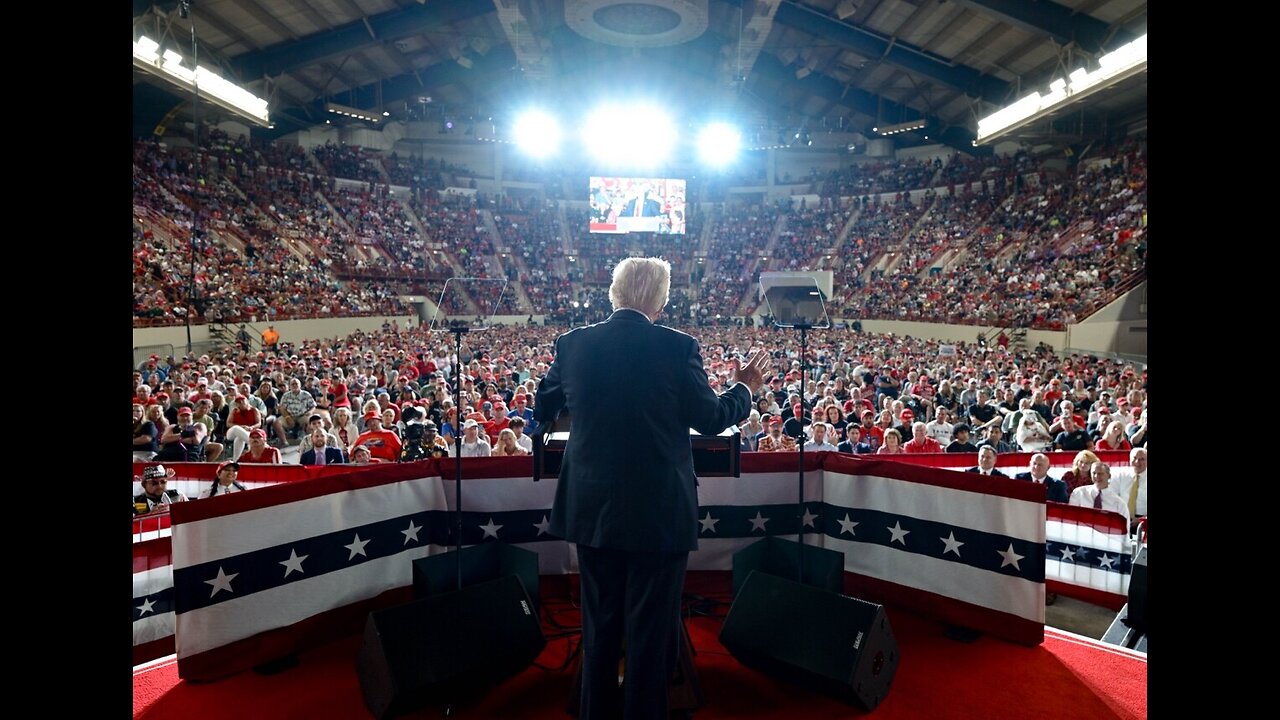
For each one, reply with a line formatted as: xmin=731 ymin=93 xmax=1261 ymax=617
xmin=356 ymin=575 xmax=547 ymax=719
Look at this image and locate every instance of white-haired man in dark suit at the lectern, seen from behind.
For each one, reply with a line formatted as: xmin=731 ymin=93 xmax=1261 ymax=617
xmin=534 ymin=258 xmax=768 ymax=720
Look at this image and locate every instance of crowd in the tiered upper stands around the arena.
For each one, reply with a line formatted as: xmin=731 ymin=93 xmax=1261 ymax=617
xmin=134 ymin=129 xmax=1146 ymax=329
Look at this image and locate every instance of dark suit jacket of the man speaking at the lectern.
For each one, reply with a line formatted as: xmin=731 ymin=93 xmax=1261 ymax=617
xmin=534 ymin=310 xmax=751 ymax=552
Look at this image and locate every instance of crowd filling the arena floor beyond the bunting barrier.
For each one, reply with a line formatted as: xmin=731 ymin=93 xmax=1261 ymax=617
xmin=133 ymin=316 xmax=1147 ymax=527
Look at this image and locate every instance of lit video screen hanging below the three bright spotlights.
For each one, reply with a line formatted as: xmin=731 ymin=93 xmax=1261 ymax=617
xmin=589 ymin=177 xmax=685 ymax=234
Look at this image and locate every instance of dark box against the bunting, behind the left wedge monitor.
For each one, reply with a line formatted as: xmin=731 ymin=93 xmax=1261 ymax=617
xmin=413 ymin=542 xmax=538 ymax=609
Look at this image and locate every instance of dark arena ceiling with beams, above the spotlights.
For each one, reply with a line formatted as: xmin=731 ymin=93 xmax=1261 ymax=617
xmin=133 ymin=0 xmax=1147 ymax=150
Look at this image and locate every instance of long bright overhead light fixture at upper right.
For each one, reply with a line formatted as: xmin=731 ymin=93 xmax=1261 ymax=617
xmin=974 ymin=35 xmax=1147 ymax=143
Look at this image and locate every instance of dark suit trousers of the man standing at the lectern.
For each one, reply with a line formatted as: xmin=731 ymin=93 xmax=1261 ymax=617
xmin=577 ymin=544 xmax=689 ymax=720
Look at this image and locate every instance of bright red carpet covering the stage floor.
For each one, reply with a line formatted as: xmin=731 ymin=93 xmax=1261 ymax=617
xmin=133 ymin=574 xmax=1147 ymax=720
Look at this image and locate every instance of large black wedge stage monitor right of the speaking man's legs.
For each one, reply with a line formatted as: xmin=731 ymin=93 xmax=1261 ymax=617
xmin=719 ymin=571 xmax=899 ymax=710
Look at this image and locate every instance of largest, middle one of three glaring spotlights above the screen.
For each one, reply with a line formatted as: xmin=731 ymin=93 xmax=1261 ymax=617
xmin=582 ymin=105 xmax=676 ymax=168
